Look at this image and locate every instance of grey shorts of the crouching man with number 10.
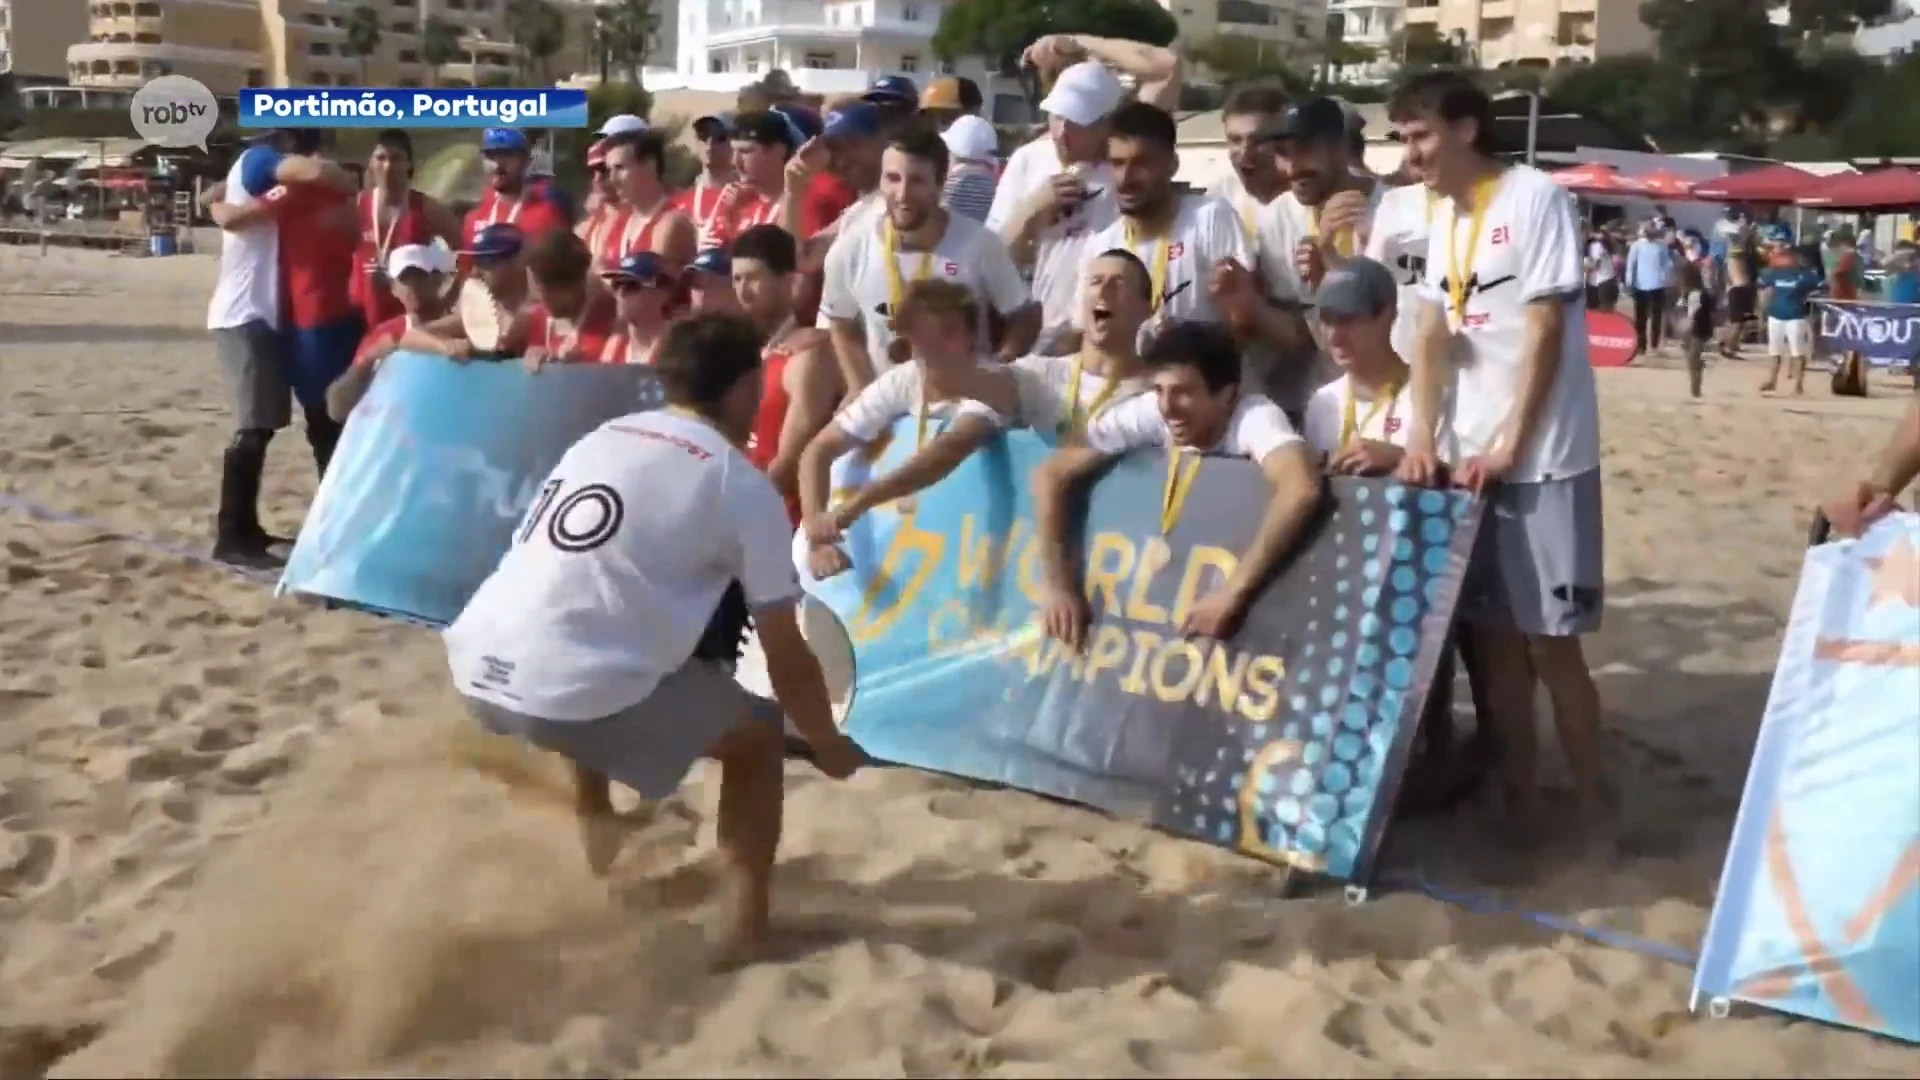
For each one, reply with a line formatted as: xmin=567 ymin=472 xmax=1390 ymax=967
xmin=463 ymin=659 xmax=785 ymax=799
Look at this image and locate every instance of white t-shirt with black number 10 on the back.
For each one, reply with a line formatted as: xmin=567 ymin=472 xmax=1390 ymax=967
xmin=444 ymin=411 xmax=801 ymax=721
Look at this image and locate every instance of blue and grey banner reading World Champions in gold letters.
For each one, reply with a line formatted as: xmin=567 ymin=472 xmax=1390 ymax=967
xmin=795 ymin=421 xmax=1480 ymax=880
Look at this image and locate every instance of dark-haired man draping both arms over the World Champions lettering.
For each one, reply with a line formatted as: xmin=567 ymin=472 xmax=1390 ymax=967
xmin=1033 ymin=315 xmax=1323 ymax=651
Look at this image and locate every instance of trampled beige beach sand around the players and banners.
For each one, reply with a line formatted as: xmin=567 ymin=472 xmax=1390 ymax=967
xmin=0 ymin=250 xmax=1920 ymax=1076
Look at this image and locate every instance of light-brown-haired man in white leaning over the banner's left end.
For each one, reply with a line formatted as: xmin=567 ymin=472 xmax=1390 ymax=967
xmin=801 ymin=281 xmax=1018 ymax=580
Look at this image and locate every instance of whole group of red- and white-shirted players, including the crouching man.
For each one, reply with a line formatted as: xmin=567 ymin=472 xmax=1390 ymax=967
xmin=211 ymin=58 xmax=1603 ymax=955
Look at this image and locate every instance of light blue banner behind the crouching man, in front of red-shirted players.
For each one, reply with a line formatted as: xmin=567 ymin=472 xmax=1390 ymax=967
xmin=278 ymin=352 xmax=659 ymax=625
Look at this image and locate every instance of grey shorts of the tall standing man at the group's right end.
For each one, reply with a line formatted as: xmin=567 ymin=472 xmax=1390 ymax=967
xmin=1461 ymin=469 xmax=1607 ymax=638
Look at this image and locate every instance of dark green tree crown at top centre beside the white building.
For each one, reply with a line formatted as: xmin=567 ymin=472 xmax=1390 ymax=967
xmin=933 ymin=0 xmax=1181 ymax=71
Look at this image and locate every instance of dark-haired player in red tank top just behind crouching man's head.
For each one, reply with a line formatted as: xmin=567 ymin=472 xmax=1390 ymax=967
xmin=730 ymin=225 xmax=841 ymax=528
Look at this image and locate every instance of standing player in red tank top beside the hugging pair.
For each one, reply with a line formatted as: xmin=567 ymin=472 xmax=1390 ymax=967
xmin=353 ymin=129 xmax=461 ymax=329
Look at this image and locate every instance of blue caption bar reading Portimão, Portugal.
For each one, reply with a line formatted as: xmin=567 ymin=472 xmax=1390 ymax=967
xmin=240 ymin=86 xmax=588 ymax=127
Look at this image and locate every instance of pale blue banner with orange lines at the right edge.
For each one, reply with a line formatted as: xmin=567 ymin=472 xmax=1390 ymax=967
xmin=1693 ymin=513 xmax=1920 ymax=1042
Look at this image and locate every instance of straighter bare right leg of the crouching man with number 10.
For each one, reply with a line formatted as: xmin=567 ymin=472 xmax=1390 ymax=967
xmin=710 ymin=719 xmax=785 ymax=967
